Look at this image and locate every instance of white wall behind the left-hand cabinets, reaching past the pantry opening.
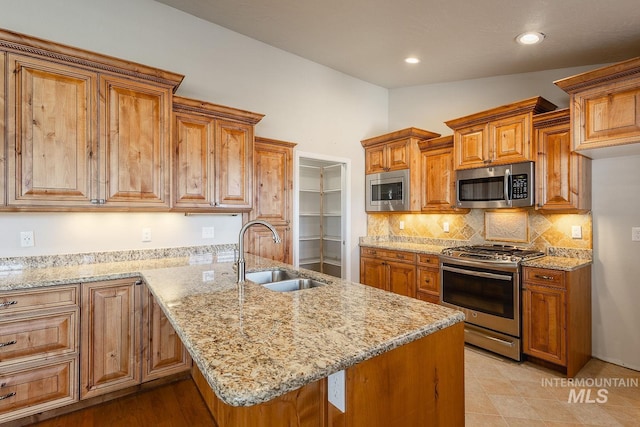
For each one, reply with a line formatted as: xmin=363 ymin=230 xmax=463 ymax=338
xmin=0 ymin=0 xmax=388 ymax=277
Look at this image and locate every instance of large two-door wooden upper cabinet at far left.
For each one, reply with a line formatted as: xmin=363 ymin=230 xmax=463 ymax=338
xmin=0 ymin=30 xmax=183 ymax=210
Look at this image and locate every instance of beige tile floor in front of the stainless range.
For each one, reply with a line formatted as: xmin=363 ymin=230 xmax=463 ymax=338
xmin=465 ymin=346 xmax=640 ymax=427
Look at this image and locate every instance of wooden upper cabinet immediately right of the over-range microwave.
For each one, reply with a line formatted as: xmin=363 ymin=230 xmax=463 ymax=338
xmin=533 ymin=108 xmax=591 ymax=213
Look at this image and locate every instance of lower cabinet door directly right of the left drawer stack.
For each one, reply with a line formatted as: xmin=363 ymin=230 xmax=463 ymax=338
xmin=80 ymin=280 xmax=142 ymax=399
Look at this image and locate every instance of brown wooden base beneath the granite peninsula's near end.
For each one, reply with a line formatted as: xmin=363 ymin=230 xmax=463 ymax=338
xmin=192 ymin=323 xmax=464 ymax=427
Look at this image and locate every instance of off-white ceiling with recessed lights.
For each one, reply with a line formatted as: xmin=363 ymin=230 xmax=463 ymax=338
xmin=157 ymin=0 xmax=640 ymax=88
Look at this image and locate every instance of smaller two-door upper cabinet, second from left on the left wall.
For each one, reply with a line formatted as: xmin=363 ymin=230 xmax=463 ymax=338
xmin=173 ymin=96 xmax=264 ymax=212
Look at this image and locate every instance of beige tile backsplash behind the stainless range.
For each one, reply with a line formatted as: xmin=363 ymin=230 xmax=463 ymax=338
xmin=367 ymin=208 xmax=593 ymax=253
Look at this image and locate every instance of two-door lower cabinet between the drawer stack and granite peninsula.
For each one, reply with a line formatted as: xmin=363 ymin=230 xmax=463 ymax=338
xmin=80 ymin=279 xmax=191 ymax=399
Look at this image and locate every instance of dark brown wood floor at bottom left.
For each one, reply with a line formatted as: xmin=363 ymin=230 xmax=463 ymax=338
xmin=32 ymin=378 xmax=216 ymax=427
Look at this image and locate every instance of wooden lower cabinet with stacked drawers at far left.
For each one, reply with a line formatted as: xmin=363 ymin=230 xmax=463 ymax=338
xmin=0 ymin=285 xmax=80 ymax=424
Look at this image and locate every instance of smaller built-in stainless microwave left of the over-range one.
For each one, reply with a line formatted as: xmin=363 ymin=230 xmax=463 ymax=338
xmin=365 ymin=169 xmax=410 ymax=212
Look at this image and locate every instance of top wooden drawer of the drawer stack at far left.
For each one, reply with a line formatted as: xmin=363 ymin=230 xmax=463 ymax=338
xmin=0 ymin=285 xmax=78 ymax=316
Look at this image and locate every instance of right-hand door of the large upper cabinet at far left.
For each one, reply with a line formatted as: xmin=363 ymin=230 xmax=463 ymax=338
xmin=100 ymin=76 xmax=171 ymax=209
